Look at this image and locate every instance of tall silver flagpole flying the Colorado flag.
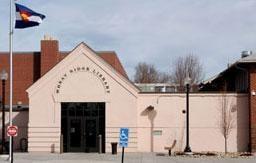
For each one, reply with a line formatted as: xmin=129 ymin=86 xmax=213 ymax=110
xmin=9 ymin=0 xmax=13 ymax=161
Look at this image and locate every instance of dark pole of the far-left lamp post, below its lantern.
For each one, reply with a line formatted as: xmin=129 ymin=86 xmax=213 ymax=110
xmin=2 ymin=80 xmax=5 ymax=153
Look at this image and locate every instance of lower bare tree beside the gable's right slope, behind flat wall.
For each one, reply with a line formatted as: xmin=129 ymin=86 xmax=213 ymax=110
xmin=134 ymin=62 xmax=170 ymax=83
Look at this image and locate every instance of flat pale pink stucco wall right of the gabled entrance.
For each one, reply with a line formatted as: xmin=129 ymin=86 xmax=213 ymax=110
xmin=137 ymin=94 xmax=248 ymax=152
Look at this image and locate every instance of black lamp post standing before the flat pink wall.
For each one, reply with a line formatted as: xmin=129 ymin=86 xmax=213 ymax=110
xmin=184 ymin=76 xmax=192 ymax=154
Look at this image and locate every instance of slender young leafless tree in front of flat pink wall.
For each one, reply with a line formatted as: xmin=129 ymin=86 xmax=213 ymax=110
xmin=219 ymin=93 xmax=236 ymax=153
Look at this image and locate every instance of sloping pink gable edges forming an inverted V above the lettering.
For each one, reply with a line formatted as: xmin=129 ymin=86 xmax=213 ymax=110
xmin=26 ymin=42 xmax=139 ymax=96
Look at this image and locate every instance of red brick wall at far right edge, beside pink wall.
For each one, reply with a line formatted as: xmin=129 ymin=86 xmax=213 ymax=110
xmin=249 ymin=66 xmax=256 ymax=152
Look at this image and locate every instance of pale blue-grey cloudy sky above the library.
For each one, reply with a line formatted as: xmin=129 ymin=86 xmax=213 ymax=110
xmin=0 ymin=0 xmax=256 ymax=79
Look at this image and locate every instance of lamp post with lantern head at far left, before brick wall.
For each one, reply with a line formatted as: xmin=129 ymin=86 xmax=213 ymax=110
xmin=0 ymin=70 xmax=8 ymax=153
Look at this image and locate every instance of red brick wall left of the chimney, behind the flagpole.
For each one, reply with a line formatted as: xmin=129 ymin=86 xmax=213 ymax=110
xmin=0 ymin=52 xmax=40 ymax=105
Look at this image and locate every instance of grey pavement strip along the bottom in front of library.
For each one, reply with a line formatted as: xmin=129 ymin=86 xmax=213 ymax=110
xmin=0 ymin=153 xmax=256 ymax=163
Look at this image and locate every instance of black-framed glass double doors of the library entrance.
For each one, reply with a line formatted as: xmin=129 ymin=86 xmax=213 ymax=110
xmin=61 ymin=102 xmax=105 ymax=152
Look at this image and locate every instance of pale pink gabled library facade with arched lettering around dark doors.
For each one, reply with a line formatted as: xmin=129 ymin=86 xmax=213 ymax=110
xmin=28 ymin=46 xmax=137 ymax=152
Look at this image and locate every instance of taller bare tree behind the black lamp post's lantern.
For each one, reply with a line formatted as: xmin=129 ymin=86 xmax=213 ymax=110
xmin=172 ymin=54 xmax=203 ymax=86
